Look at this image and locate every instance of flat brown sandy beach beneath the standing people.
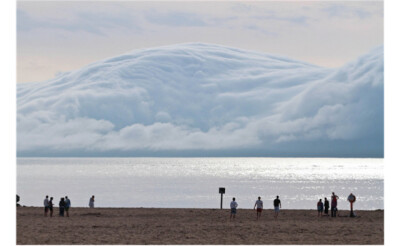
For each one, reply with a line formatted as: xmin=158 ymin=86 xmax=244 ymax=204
xmin=17 ymin=207 xmax=384 ymax=244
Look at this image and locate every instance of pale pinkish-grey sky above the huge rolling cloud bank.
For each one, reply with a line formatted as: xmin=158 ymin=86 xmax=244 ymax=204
xmin=17 ymin=1 xmax=383 ymax=83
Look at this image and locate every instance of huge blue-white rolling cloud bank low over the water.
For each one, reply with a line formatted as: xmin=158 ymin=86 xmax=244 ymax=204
xmin=17 ymin=43 xmax=383 ymax=157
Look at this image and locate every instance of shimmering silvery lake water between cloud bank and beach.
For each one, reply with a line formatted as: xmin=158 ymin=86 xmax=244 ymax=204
xmin=17 ymin=158 xmax=384 ymax=210
